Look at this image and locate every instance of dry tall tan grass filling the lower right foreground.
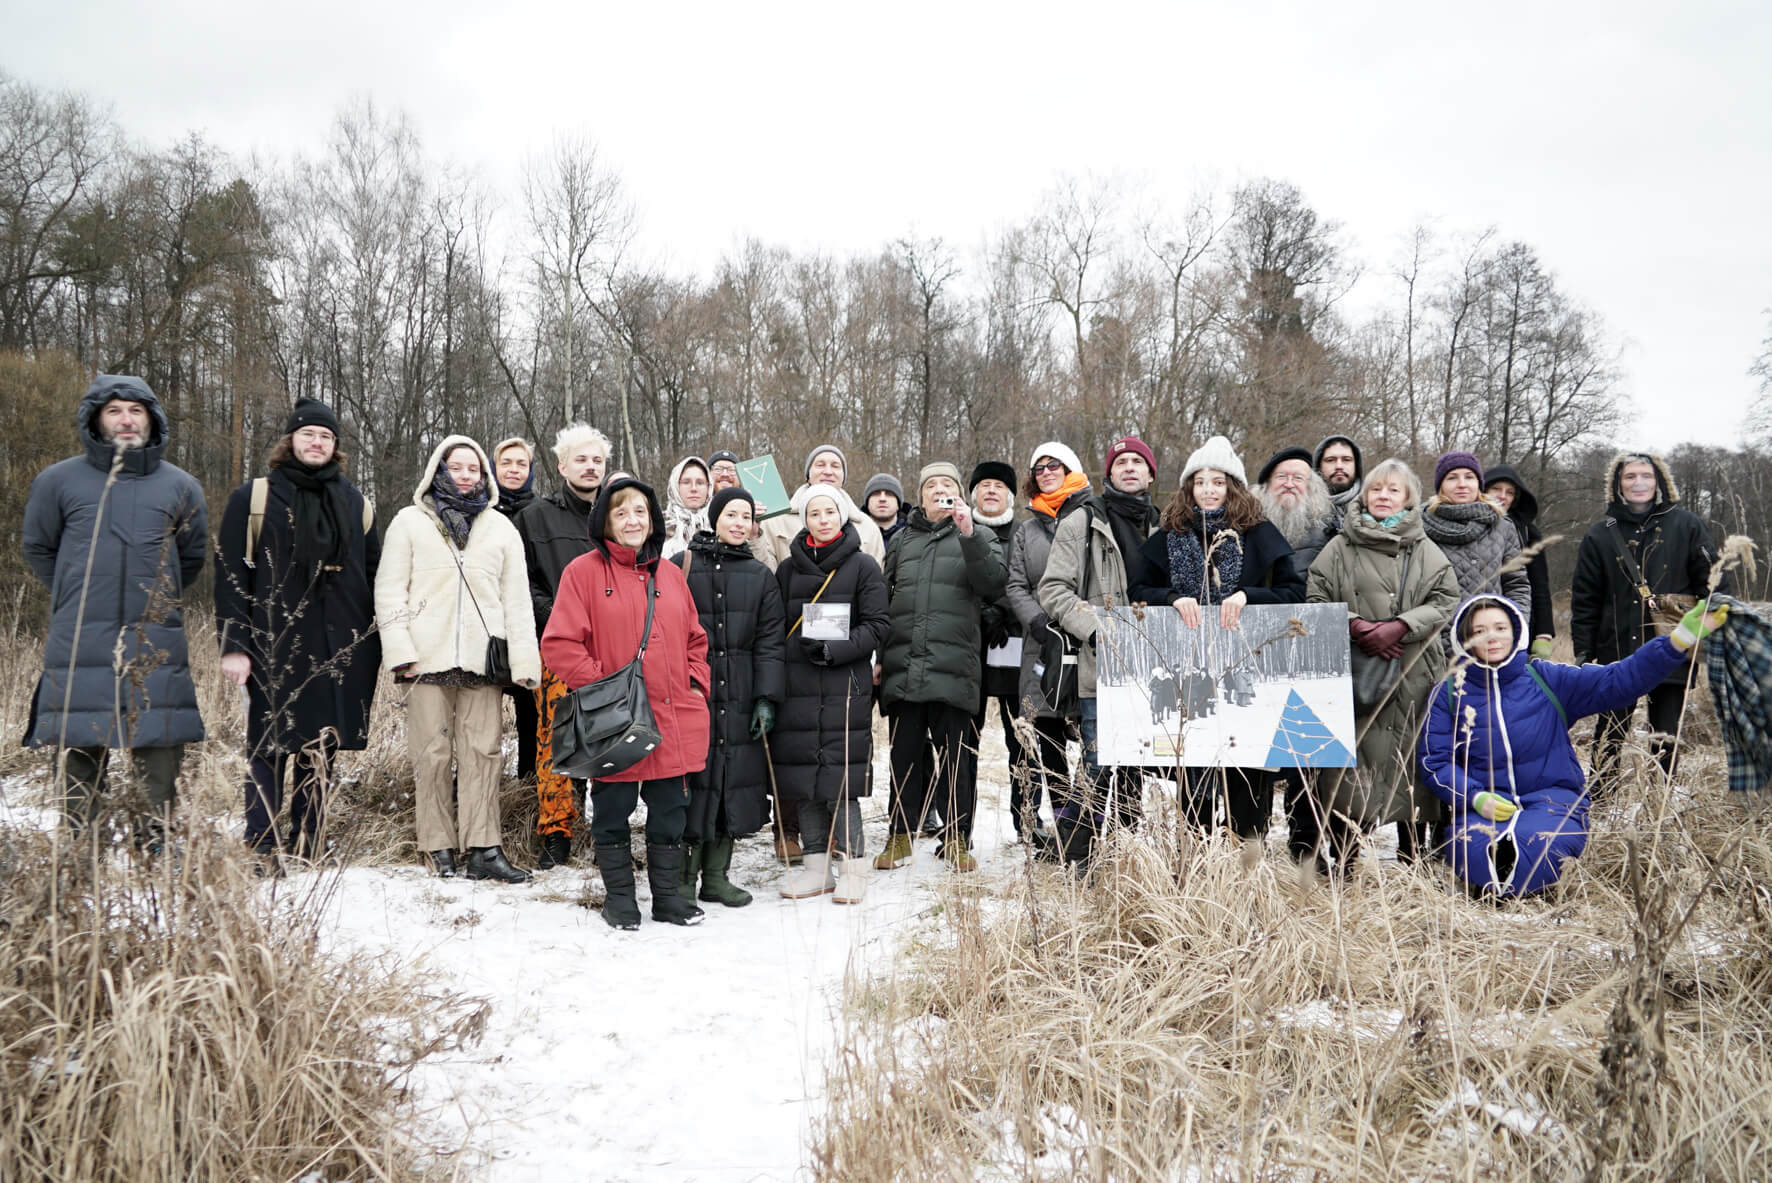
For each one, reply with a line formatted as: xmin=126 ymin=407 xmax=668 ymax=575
xmin=813 ymin=726 xmax=1772 ymax=1179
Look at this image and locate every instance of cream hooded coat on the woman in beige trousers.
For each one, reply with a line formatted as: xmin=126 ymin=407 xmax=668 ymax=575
xmin=376 ymin=436 xmax=542 ymax=689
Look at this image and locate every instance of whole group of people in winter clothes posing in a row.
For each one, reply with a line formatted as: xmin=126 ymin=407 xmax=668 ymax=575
xmin=23 ymin=375 xmax=1726 ymax=928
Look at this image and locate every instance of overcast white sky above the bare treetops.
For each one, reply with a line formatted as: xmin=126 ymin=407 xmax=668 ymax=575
xmin=0 ymin=0 xmax=1772 ymax=446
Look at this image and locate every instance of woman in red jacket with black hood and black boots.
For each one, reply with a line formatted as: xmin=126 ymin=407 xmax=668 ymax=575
xmin=542 ymin=476 xmax=709 ymax=928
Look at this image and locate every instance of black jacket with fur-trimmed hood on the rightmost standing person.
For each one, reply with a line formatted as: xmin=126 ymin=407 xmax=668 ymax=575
xmin=1568 ymin=453 xmax=1729 ymax=682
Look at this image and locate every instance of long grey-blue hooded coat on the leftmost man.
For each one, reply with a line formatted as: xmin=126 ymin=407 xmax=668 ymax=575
xmin=21 ymin=374 xmax=209 ymax=747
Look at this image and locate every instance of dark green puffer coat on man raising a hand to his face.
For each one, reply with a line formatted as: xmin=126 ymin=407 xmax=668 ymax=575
xmin=881 ymin=510 xmax=1008 ymax=714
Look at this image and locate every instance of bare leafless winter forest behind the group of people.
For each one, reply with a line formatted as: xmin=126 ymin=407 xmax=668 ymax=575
xmin=0 ymin=66 xmax=1772 ymax=602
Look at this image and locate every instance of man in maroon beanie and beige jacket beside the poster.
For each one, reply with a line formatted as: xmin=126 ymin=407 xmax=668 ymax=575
xmin=1035 ymin=436 xmax=1161 ymax=864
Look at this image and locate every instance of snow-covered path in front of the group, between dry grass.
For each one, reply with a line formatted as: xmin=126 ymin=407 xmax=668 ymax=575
xmin=318 ymin=726 xmax=1022 ymax=1183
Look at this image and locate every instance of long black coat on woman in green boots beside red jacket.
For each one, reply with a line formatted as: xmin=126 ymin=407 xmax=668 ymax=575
xmin=670 ymin=530 xmax=787 ymax=841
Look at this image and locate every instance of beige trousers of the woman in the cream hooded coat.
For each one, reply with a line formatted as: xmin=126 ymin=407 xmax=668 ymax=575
xmin=406 ymin=682 xmax=505 ymax=850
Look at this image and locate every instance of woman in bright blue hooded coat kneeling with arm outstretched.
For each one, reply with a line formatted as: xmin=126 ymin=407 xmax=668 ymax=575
xmin=1419 ymin=595 xmax=1728 ymax=896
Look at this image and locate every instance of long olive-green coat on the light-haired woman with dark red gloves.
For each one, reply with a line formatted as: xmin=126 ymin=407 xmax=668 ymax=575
xmin=1304 ymin=510 xmax=1458 ymax=829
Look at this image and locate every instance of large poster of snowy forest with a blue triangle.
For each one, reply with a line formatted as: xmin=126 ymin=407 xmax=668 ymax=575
xmin=1095 ymin=604 xmax=1354 ymax=769
